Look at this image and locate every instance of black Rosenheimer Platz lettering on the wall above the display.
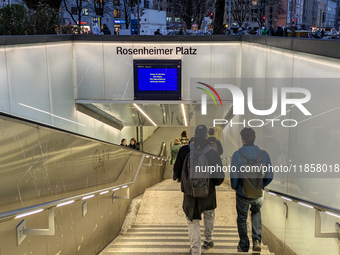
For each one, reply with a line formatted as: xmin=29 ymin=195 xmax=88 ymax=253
xmin=116 ymin=47 xmax=197 ymax=55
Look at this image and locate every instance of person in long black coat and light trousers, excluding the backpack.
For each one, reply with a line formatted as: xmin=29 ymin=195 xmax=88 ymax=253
xmin=174 ymin=125 xmax=224 ymax=255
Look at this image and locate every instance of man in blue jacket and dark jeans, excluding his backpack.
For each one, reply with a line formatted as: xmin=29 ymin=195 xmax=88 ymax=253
xmin=230 ymin=128 xmax=273 ymax=252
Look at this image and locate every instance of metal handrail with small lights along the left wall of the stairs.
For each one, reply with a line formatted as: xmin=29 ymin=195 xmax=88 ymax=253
xmin=0 ymin=153 xmax=164 ymax=223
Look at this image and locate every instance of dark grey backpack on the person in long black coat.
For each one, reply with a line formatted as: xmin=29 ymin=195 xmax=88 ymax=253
xmin=181 ymin=143 xmax=212 ymax=198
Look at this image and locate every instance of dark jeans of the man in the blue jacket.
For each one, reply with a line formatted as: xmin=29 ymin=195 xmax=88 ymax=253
xmin=236 ymin=194 xmax=263 ymax=252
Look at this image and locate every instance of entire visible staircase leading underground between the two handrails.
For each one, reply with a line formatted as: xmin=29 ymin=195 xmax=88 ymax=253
xmin=100 ymin=179 xmax=274 ymax=255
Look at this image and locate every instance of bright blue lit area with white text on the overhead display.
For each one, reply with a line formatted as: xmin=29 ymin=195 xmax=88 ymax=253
xmin=138 ymin=68 xmax=177 ymax=91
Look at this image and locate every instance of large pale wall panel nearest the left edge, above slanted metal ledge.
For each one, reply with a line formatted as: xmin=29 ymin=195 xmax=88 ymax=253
xmin=6 ymin=44 xmax=51 ymax=124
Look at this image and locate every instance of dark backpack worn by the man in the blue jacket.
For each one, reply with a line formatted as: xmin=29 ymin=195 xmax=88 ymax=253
xmin=238 ymin=150 xmax=264 ymax=198
